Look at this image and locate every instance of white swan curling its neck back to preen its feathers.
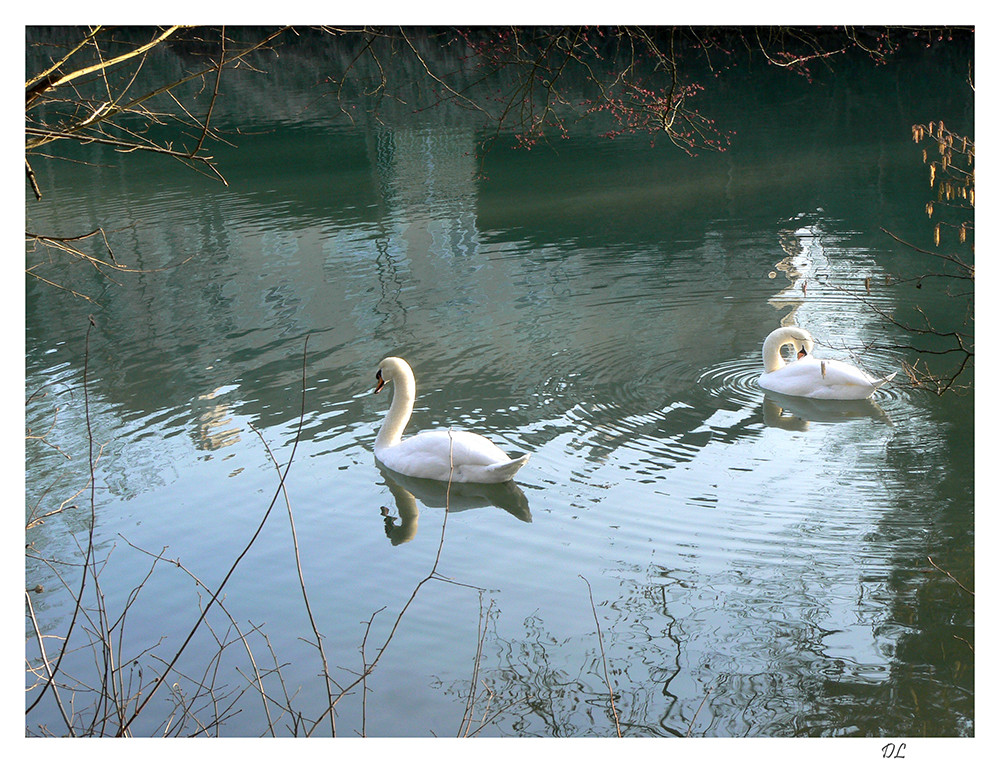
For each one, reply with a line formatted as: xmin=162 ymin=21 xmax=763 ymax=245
xmin=759 ymin=326 xmax=896 ymax=400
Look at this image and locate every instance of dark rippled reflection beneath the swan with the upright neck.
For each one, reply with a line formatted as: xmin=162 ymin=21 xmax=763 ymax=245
xmin=376 ymin=461 xmax=531 ymax=546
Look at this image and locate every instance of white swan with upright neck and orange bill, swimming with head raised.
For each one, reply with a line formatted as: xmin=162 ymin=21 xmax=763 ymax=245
xmin=375 ymin=358 xmax=529 ymax=483
